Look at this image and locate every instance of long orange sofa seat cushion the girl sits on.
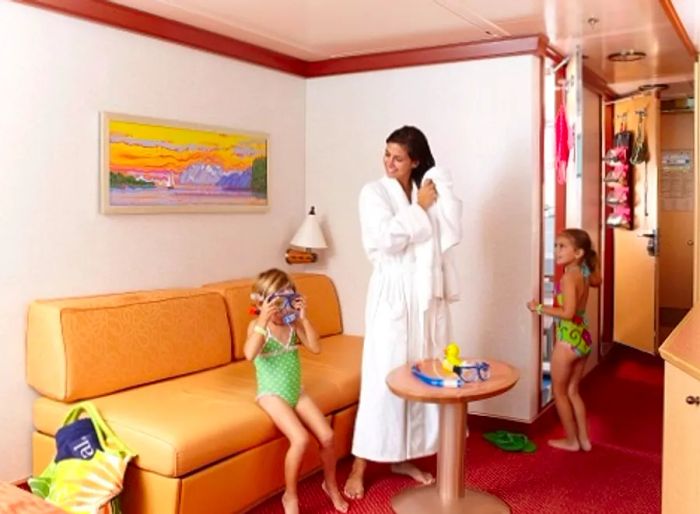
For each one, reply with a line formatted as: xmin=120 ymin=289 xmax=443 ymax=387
xmin=34 ymin=335 xmax=362 ymax=477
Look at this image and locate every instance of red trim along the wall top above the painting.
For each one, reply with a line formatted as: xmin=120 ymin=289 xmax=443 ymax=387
xmin=15 ymin=0 xmax=306 ymax=76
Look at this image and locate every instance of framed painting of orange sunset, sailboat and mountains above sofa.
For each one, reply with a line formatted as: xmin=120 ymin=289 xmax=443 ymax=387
xmin=100 ymin=112 xmax=269 ymax=214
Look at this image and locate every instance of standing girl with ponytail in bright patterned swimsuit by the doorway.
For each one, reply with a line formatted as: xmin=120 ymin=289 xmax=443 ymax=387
xmin=527 ymin=228 xmax=601 ymax=451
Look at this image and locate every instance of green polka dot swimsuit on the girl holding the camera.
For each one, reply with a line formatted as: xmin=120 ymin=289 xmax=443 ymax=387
xmin=253 ymin=328 xmax=301 ymax=407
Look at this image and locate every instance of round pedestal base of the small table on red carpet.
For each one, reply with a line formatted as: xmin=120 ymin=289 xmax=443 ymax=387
xmin=391 ymin=485 xmax=510 ymax=514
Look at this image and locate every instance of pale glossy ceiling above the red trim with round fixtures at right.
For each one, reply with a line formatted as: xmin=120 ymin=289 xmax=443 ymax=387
xmin=106 ymin=0 xmax=700 ymax=96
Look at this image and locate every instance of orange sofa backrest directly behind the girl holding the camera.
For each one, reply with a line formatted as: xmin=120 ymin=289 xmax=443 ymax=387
xmin=204 ymin=273 xmax=343 ymax=360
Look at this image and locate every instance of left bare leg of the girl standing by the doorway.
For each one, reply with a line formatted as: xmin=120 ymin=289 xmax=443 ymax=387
xmin=548 ymin=341 xmax=581 ymax=452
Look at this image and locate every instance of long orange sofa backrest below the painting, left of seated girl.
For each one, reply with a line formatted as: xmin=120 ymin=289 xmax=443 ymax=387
xmin=27 ymin=288 xmax=231 ymax=402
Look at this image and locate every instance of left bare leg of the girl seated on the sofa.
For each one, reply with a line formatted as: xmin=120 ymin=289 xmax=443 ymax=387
xmin=258 ymin=395 xmax=309 ymax=514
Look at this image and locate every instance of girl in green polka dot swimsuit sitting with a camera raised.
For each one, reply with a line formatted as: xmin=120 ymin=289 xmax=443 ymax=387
xmin=243 ymin=269 xmax=348 ymax=514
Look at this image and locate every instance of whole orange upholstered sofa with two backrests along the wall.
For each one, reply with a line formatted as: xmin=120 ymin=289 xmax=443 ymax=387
xmin=27 ymin=274 xmax=362 ymax=514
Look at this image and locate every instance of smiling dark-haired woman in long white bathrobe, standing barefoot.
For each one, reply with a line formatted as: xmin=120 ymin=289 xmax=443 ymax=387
xmin=345 ymin=127 xmax=438 ymax=499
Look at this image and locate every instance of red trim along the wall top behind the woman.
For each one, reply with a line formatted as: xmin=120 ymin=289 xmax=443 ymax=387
xmin=306 ymin=35 xmax=547 ymax=77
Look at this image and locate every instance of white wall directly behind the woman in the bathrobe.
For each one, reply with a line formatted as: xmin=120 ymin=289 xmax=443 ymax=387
xmin=306 ymin=56 xmax=541 ymax=420
